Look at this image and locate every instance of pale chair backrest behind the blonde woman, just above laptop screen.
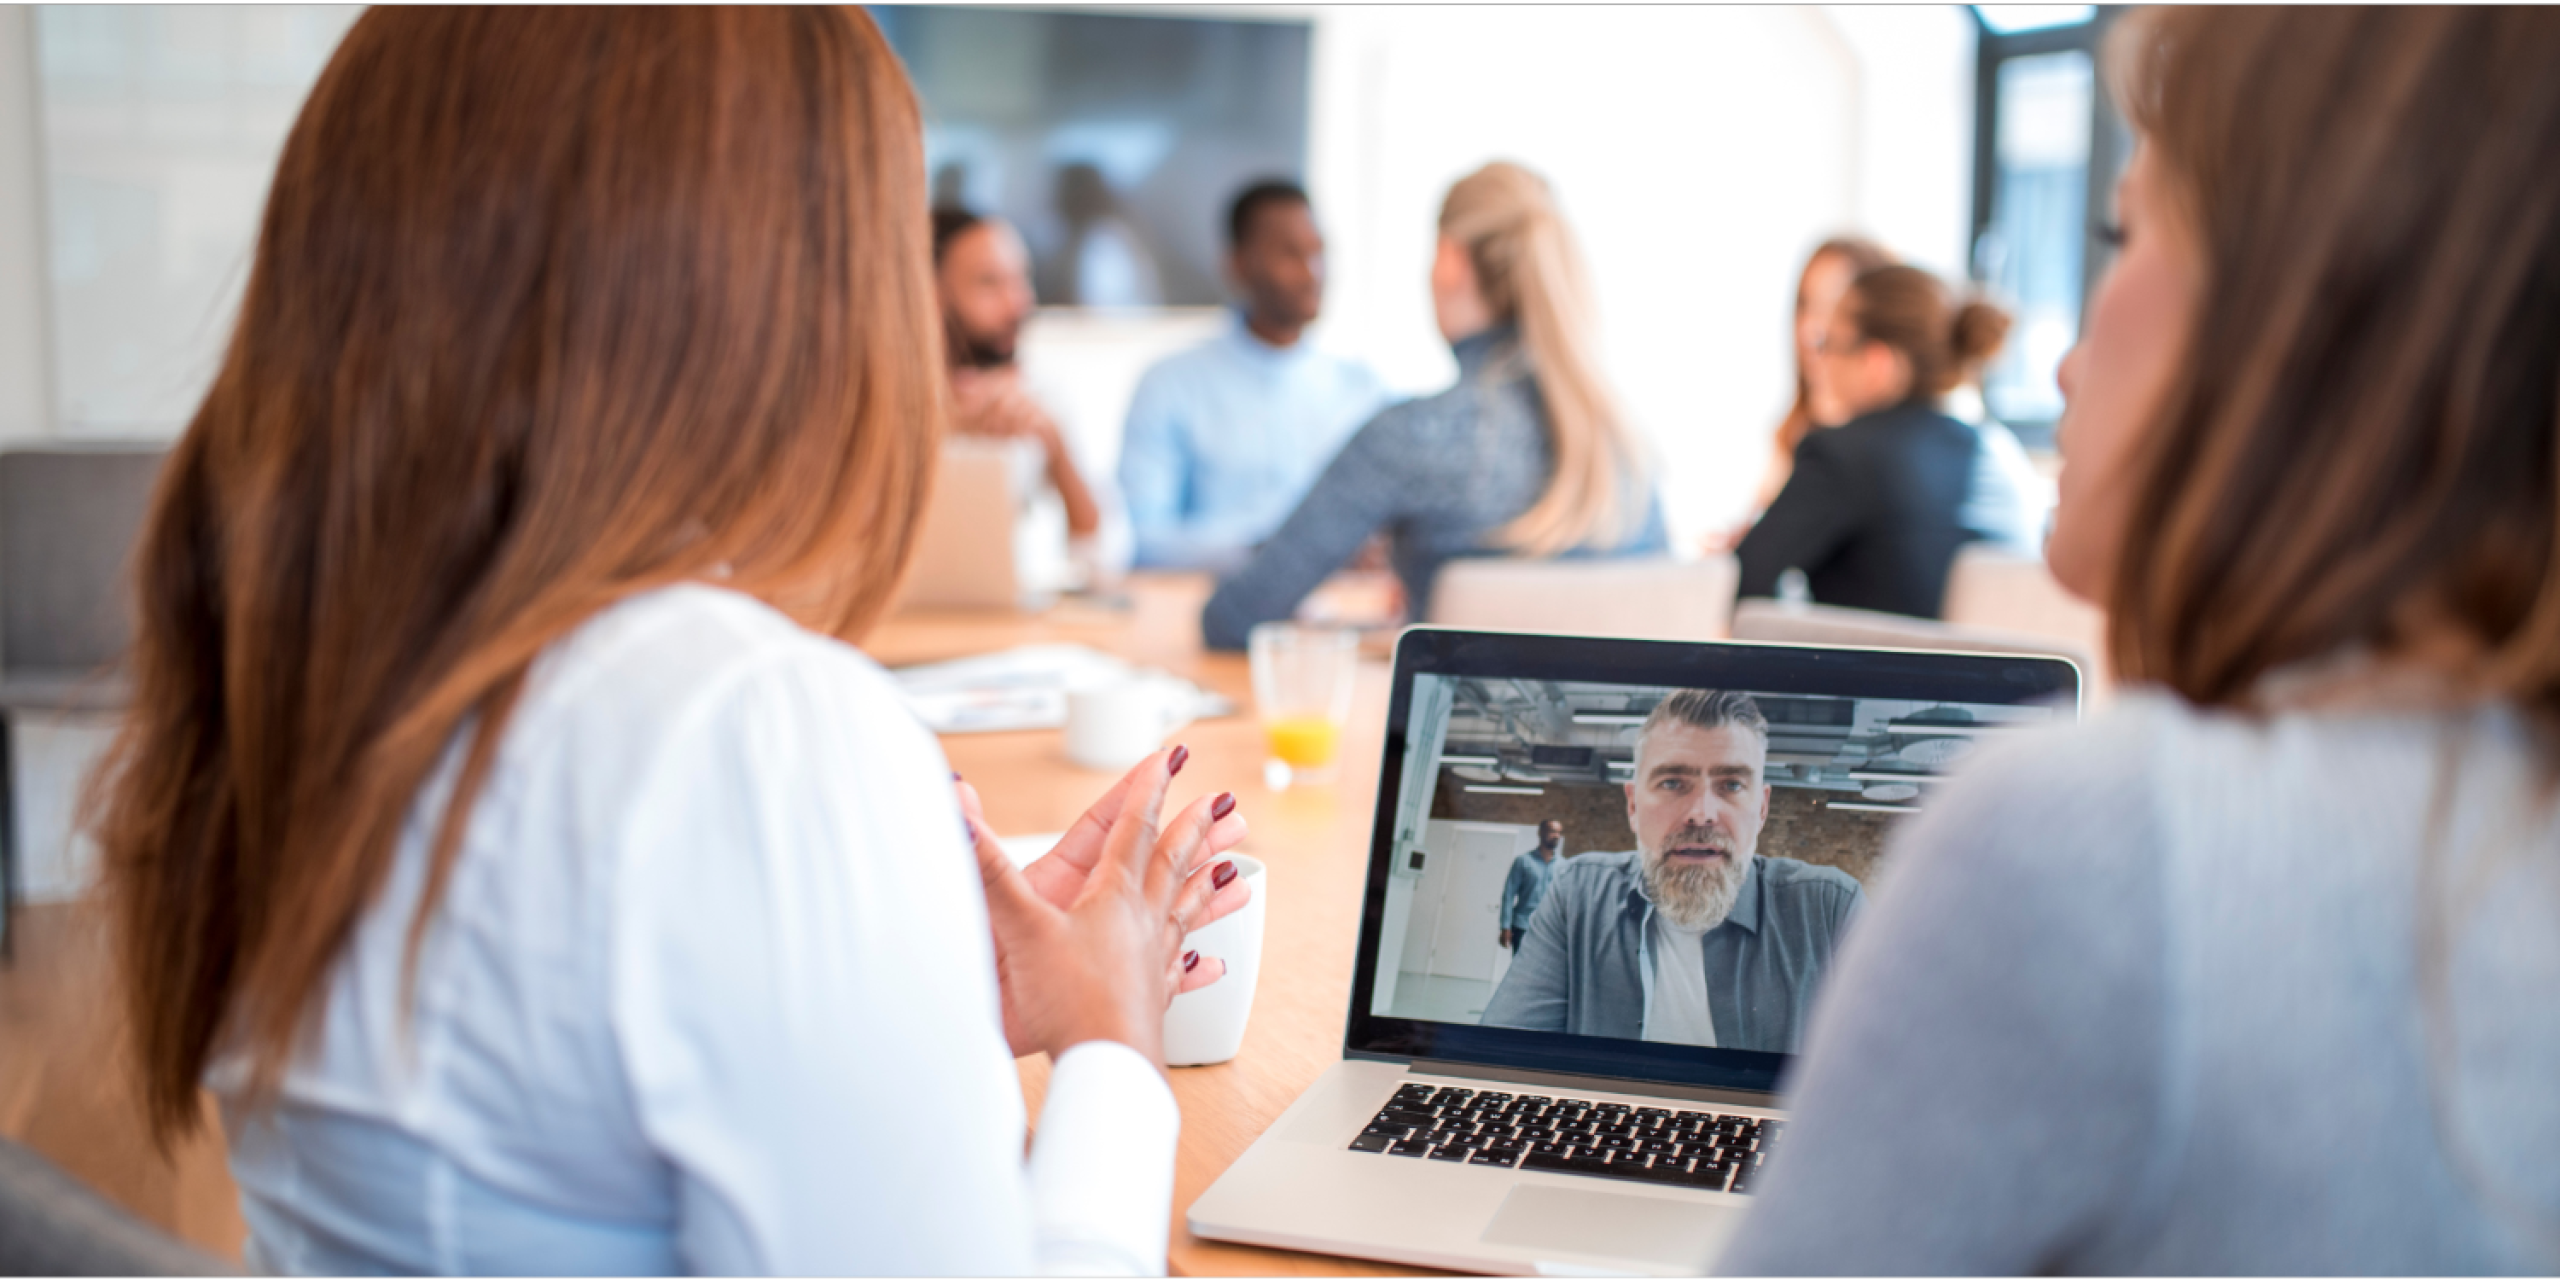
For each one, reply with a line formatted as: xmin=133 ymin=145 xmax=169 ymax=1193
xmin=1431 ymin=556 xmax=1741 ymax=640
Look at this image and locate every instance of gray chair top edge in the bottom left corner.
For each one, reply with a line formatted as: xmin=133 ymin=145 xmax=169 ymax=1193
xmin=0 ymin=1139 xmax=241 ymax=1275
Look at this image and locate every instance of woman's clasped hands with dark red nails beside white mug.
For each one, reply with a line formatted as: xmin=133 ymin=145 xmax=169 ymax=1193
xmin=957 ymin=748 xmax=1249 ymax=1060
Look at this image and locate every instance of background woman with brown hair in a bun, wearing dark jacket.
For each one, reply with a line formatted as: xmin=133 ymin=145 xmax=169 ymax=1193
xmin=1736 ymin=266 xmax=2010 ymax=617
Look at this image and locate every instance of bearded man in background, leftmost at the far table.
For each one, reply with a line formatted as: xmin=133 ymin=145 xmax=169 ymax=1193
xmin=934 ymin=207 xmax=1126 ymax=579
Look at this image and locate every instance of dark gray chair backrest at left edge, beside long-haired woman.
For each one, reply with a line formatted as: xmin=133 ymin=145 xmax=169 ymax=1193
xmin=0 ymin=445 xmax=169 ymax=671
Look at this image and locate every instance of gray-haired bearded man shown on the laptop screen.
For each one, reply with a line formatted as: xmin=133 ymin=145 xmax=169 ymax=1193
xmin=1482 ymin=689 xmax=1864 ymax=1052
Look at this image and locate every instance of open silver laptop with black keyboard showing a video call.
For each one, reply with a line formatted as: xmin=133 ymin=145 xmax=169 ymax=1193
xmin=1188 ymin=630 xmax=2081 ymax=1275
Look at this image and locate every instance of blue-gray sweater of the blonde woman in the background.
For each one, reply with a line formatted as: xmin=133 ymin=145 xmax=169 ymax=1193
xmin=1201 ymin=325 xmax=1667 ymax=648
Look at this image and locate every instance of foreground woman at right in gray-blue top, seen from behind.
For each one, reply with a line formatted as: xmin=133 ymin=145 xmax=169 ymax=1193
xmin=1720 ymin=8 xmax=2560 ymax=1275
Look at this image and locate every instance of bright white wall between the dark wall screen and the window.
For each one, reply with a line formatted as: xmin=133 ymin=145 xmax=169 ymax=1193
xmin=1308 ymin=5 xmax=1971 ymax=545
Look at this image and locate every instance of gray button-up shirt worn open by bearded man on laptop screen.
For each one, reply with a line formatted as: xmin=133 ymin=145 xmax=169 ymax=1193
xmin=1482 ymin=850 xmax=1866 ymax=1052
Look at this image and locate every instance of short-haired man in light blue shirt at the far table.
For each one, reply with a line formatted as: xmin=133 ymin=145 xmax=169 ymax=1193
xmin=1119 ymin=182 xmax=1388 ymax=571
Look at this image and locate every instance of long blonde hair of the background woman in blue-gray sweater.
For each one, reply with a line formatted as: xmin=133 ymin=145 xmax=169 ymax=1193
xmin=1439 ymin=161 xmax=1651 ymax=556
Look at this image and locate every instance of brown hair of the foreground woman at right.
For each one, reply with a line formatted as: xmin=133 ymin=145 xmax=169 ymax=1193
xmin=2107 ymin=5 xmax=2560 ymax=732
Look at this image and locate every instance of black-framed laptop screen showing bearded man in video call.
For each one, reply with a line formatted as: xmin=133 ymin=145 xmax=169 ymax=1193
xmin=1349 ymin=632 xmax=2079 ymax=1088
